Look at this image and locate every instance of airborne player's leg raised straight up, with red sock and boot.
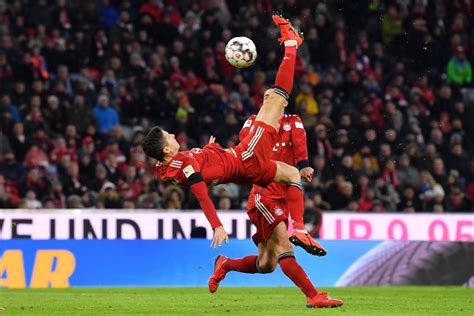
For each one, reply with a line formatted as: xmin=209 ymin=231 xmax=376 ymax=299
xmin=256 ymin=15 xmax=303 ymax=131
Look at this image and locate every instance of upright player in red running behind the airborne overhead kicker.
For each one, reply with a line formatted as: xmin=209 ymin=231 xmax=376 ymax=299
xmin=208 ymin=115 xmax=343 ymax=308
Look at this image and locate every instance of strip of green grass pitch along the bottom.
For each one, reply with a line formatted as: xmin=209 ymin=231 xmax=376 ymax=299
xmin=0 ymin=287 xmax=474 ymax=315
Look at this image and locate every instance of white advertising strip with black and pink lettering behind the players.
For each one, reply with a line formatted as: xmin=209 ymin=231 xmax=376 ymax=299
xmin=0 ymin=210 xmax=474 ymax=241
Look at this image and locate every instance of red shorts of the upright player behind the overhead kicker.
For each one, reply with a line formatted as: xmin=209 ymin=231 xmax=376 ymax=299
xmin=247 ymin=193 xmax=288 ymax=246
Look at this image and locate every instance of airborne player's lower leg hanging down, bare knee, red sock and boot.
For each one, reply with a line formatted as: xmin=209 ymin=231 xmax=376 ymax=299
xmin=274 ymin=161 xmax=327 ymax=256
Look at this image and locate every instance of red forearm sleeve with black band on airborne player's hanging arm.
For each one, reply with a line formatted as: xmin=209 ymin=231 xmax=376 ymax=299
xmin=188 ymin=172 xmax=222 ymax=229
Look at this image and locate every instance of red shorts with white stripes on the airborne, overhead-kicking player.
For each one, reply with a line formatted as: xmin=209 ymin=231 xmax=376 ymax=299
xmin=234 ymin=121 xmax=278 ymax=187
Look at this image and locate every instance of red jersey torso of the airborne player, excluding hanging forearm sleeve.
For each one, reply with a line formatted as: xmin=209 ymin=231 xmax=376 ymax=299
xmin=156 ymin=144 xmax=242 ymax=185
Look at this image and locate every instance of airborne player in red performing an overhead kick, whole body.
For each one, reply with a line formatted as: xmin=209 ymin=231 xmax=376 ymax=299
xmin=142 ymin=15 xmax=325 ymax=255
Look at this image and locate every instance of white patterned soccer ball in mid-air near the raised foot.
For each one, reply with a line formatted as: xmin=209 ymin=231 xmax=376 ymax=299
xmin=225 ymin=36 xmax=257 ymax=68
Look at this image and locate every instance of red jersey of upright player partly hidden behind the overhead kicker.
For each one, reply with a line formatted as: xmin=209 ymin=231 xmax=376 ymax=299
xmin=239 ymin=114 xmax=309 ymax=199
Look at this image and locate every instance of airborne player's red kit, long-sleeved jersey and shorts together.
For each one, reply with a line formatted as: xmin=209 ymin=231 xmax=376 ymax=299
xmin=155 ymin=122 xmax=278 ymax=228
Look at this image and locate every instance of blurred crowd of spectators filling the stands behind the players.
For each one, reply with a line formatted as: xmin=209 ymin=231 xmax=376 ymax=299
xmin=0 ymin=0 xmax=474 ymax=217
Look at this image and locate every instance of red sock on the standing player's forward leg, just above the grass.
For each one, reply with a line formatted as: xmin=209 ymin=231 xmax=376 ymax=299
xmin=278 ymin=253 xmax=318 ymax=298
